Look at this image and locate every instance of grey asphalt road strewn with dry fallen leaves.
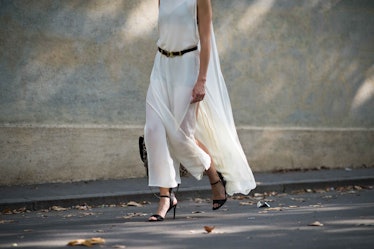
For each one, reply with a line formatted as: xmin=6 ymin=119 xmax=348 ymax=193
xmin=0 ymin=187 xmax=374 ymax=249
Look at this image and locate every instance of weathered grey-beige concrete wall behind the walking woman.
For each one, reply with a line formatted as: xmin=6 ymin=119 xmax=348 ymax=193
xmin=0 ymin=0 xmax=374 ymax=185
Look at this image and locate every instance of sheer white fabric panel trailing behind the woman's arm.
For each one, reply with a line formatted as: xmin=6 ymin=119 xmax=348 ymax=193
xmin=195 ymin=26 xmax=256 ymax=195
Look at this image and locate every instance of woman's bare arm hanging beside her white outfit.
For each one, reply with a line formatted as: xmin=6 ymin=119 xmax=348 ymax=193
xmin=191 ymin=0 xmax=212 ymax=103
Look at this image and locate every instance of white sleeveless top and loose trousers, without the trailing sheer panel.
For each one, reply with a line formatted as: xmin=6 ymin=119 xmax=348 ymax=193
xmin=144 ymin=0 xmax=211 ymax=188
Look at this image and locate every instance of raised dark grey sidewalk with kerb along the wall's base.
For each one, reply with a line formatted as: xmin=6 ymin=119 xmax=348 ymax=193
xmin=0 ymin=168 xmax=374 ymax=211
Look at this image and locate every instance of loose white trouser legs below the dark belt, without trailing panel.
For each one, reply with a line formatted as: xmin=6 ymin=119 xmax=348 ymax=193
xmin=144 ymin=51 xmax=211 ymax=188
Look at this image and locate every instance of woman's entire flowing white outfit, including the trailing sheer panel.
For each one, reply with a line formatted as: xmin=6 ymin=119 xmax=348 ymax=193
xmin=144 ymin=0 xmax=256 ymax=195
